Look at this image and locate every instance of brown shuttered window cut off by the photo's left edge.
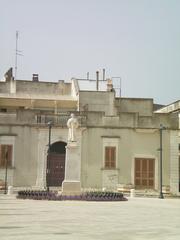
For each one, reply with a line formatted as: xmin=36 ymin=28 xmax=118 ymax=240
xmin=0 ymin=144 xmax=12 ymax=168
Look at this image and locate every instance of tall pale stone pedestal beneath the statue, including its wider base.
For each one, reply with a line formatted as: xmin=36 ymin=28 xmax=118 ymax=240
xmin=62 ymin=142 xmax=81 ymax=195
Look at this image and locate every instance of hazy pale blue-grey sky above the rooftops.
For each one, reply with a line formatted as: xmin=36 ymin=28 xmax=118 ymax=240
xmin=0 ymin=0 xmax=180 ymax=104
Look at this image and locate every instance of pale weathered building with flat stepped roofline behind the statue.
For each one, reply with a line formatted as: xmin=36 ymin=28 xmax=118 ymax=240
xmin=0 ymin=70 xmax=180 ymax=194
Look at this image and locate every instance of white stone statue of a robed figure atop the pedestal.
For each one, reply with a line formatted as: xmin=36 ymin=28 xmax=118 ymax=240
xmin=67 ymin=113 xmax=79 ymax=142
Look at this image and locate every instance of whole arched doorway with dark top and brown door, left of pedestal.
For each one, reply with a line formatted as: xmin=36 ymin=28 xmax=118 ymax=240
xmin=46 ymin=142 xmax=67 ymax=187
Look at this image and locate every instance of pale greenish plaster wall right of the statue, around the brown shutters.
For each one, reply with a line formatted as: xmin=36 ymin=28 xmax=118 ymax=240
xmin=82 ymin=128 xmax=170 ymax=189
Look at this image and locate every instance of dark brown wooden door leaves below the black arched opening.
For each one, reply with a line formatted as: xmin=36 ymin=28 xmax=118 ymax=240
xmin=47 ymin=153 xmax=65 ymax=186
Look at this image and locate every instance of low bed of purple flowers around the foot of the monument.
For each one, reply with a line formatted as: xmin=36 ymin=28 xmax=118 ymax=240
xmin=17 ymin=190 xmax=127 ymax=201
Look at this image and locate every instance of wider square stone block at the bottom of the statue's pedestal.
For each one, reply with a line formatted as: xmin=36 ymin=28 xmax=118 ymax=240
xmin=62 ymin=180 xmax=81 ymax=195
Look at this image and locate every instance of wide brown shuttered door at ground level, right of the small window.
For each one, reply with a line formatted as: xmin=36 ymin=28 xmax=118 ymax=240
xmin=135 ymin=158 xmax=155 ymax=189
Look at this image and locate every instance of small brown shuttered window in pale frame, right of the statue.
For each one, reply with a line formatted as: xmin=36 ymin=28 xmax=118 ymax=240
xmin=105 ymin=147 xmax=116 ymax=168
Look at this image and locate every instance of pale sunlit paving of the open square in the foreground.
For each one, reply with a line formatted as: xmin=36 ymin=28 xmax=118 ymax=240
xmin=0 ymin=194 xmax=180 ymax=240
